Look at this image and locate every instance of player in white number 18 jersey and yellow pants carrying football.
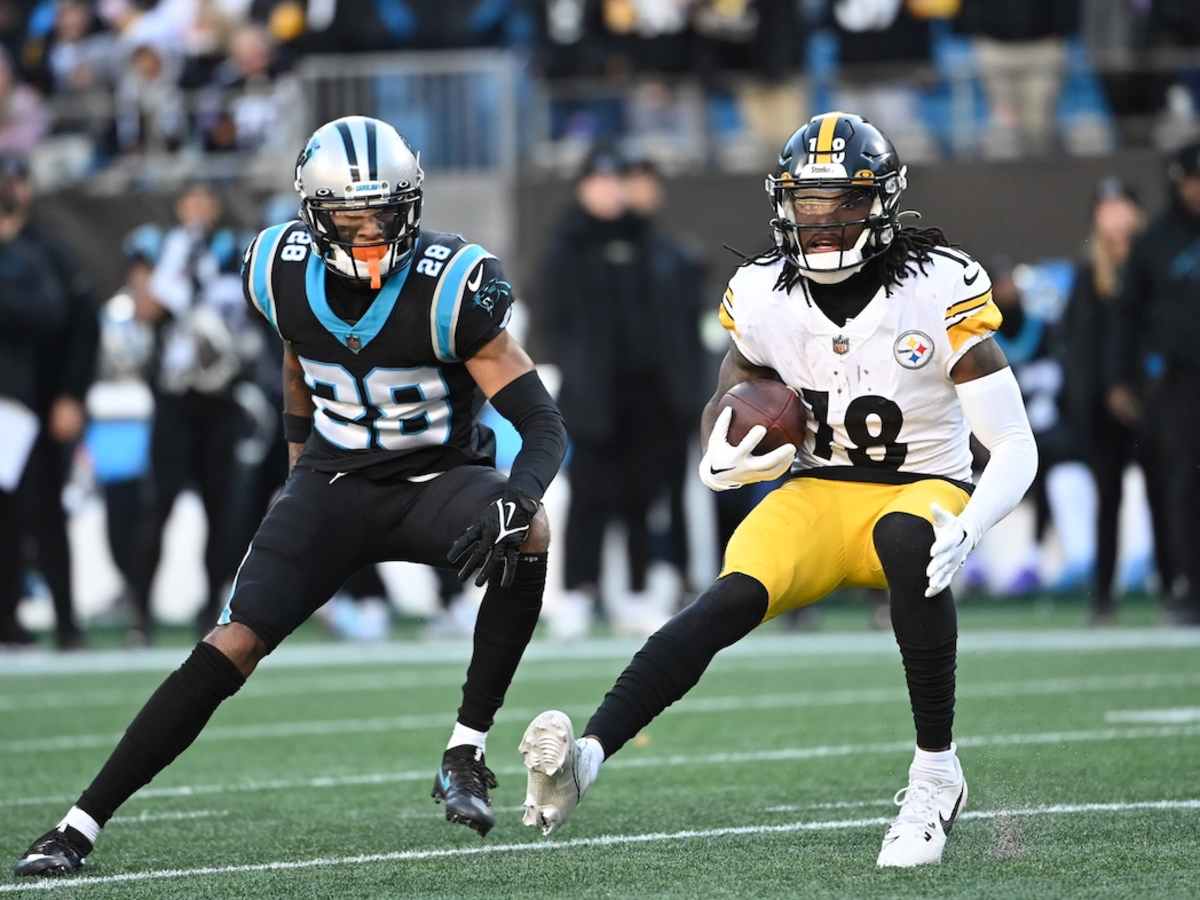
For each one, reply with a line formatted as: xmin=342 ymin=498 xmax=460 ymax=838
xmin=521 ymin=113 xmax=1037 ymax=866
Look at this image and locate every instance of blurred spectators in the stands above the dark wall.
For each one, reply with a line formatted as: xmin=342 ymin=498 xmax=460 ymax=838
xmin=0 ymin=0 xmax=1200 ymax=184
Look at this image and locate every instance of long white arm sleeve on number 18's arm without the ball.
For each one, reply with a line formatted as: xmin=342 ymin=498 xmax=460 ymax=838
xmin=955 ymin=366 xmax=1038 ymax=541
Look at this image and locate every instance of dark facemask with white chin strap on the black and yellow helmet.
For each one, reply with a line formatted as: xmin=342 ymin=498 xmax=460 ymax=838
xmin=767 ymin=169 xmax=905 ymax=284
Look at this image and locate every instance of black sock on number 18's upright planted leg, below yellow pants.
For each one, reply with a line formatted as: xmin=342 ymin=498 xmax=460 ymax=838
xmin=874 ymin=512 xmax=959 ymax=750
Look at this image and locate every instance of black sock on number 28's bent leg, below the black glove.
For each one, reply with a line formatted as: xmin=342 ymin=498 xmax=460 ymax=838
xmin=458 ymin=553 xmax=547 ymax=731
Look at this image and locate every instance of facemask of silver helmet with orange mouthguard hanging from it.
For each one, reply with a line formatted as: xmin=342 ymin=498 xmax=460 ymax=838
xmin=300 ymin=188 xmax=421 ymax=290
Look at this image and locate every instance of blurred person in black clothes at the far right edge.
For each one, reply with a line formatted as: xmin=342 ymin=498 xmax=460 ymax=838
xmin=1108 ymin=140 xmax=1200 ymax=625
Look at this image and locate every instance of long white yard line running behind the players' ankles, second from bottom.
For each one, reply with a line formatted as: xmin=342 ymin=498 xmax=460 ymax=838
xmin=0 ymin=725 xmax=1200 ymax=809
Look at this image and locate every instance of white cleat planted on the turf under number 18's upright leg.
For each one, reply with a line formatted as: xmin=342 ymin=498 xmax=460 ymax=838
xmin=875 ymin=758 xmax=967 ymax=868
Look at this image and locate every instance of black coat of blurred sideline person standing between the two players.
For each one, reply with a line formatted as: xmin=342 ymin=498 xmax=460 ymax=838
xmin=541 ymin=209 xmax=706 ymax=440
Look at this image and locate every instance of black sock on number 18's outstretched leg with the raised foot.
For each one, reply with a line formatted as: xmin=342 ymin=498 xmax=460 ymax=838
xmin=583 ymin=572 xmax=767 ymax=756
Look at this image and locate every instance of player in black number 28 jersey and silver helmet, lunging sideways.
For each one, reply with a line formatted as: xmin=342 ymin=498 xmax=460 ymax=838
xmin=16 ymin=116 xmax=566 ymax=875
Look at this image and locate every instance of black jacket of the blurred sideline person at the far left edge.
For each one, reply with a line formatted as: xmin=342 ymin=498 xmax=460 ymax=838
xmin=0 ymin=235 xmax=67 ymax=410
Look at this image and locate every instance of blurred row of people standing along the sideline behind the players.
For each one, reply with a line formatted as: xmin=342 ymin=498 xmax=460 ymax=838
xmin=0 ymin=132 xmax=1200 ymax=648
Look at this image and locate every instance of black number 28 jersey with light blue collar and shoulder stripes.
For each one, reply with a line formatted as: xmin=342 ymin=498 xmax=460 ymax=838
xmin=242 ymin=221 xmax=512 ymax=476
